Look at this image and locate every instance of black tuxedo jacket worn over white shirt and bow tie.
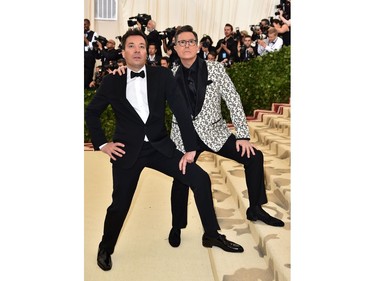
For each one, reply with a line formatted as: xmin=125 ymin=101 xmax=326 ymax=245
xmin=85 ymin=66 xmax=197 ymax=168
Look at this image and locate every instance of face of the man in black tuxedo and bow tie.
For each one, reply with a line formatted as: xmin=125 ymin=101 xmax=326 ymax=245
xmin=122 ymin=35 xmax=147 ymax=71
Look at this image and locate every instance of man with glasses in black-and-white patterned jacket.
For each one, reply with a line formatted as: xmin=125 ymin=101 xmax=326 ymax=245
xmin=168 ymin=25 xmax=284 ymax=247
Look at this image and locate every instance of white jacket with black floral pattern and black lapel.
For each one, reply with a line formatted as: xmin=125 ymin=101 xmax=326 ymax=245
xmin=171 ymin=58 xmax=250 ymax=152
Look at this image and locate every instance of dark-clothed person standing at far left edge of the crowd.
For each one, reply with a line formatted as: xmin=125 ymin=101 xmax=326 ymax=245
xmin=83 ymin=19 xmax=98 ymax=89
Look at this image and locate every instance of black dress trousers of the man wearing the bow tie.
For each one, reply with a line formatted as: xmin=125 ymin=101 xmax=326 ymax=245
xmin=99 ymin=142 xmax=220 ymax=254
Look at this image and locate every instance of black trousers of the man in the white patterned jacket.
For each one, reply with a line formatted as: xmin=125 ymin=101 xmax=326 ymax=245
xmin=171 ymin=134 xmax=267 ymax=228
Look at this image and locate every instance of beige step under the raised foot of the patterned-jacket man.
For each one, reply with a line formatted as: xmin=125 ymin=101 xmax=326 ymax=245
xmin=215 ymin=155 xmax=290 ymax=281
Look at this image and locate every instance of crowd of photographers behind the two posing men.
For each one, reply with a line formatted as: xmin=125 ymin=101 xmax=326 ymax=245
xmin=84 ymin=0 xmax=291 ymax=89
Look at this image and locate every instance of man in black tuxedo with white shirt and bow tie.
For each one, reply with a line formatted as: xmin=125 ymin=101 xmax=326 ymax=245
xmin=85 ymin=29 xmax=243 ymax=270
